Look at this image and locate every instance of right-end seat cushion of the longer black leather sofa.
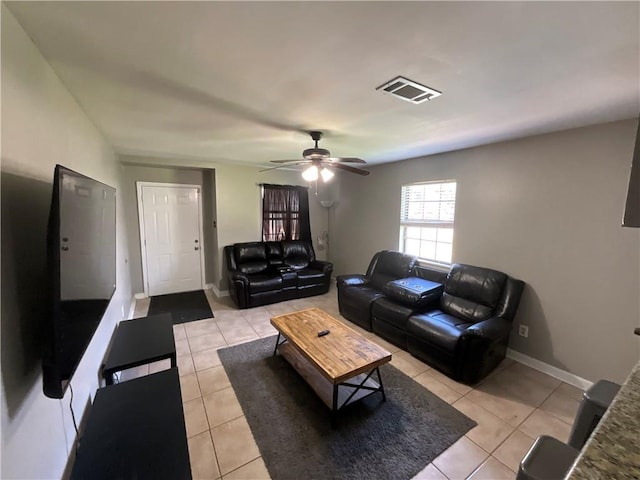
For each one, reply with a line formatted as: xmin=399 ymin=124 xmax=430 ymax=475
xmin=407 ymin=310 xmax=472 ymax=352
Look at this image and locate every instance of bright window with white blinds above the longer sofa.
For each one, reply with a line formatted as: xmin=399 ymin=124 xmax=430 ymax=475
xmin=400 ymin=180 xmax=456 ymax=265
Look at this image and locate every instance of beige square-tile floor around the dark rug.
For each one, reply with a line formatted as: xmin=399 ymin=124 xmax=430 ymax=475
xmin=121 ymin=287 xmax=582 ymax=480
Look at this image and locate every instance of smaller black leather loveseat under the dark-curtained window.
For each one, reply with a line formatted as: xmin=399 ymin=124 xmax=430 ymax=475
xmin=224 ymin=240 xmax=333 ymax=308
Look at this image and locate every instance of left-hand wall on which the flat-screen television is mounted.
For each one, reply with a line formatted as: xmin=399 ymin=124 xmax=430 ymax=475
xmin=0 ymin=4 xmax=132 ymax=479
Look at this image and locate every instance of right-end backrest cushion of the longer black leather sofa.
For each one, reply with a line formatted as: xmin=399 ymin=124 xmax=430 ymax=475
xmin=440 ymin=264 xmax=507 ymax=323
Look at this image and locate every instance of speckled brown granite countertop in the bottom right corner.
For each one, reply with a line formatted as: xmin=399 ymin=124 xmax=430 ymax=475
xmin=567 ymin=362 xmax=640 ymax=480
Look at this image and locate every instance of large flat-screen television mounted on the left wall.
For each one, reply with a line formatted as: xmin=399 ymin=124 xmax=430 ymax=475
xmin=42 ymin=165 xmax=116 ymax=398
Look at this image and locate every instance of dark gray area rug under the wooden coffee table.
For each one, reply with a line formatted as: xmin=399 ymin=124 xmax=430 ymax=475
xmin=218 ymin=336 xmax=476 ymax=480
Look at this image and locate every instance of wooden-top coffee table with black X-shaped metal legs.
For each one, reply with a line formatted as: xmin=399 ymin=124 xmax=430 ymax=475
xmin=271 ymin=308 xmax=391 ymax=425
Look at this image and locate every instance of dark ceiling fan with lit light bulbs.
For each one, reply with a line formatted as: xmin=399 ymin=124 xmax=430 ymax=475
xmin=261 ymin=130 xmax=369 ymax=182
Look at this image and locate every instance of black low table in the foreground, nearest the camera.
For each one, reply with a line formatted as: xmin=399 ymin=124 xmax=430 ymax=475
xmin=71 ymin=367 xmax=191 ymax=480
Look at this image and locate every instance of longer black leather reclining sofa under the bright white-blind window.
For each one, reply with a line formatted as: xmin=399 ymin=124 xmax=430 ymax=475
xmin=337 ymin=250 xmax=524 ymax=384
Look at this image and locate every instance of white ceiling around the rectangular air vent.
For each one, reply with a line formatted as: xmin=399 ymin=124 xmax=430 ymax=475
xmin=7 ymin=2 xmax=640 ymax=171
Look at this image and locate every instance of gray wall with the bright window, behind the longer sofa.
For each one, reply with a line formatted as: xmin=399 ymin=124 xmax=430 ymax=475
xmin=330 ymin=120 xmax=640 ymax=381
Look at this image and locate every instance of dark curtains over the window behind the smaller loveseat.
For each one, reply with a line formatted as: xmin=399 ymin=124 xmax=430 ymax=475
xmin=262 ymin=185 xmax=311 ymax=242
